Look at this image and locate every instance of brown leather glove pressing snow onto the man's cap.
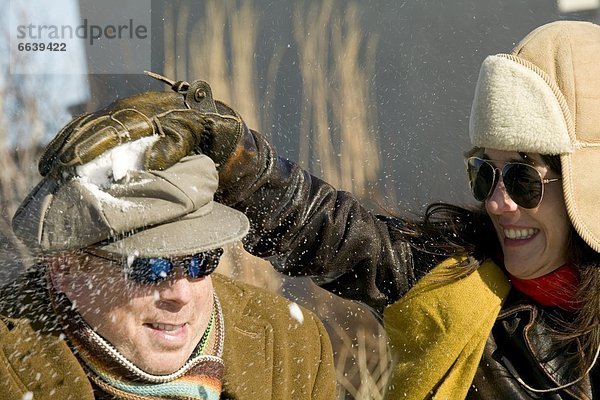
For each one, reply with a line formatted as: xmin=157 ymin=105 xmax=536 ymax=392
xmin=38 ymin=72 xmax=247 ymax=176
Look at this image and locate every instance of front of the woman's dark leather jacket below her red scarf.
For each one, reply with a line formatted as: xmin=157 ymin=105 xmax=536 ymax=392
xmin=467 ymin=289 xmax=600 ymax=400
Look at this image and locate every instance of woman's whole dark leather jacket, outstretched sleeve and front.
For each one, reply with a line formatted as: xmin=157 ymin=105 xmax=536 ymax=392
xmin=217 ymin=131 xmax=600 ymax=399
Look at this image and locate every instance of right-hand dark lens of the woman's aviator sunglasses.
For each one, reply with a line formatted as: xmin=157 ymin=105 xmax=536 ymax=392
xmin=503 ymin=164 xmax=543 ymax=208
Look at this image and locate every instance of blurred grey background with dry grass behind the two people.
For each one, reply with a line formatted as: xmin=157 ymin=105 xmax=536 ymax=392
xmin=0 ymin=0 xmax=600 ymax=399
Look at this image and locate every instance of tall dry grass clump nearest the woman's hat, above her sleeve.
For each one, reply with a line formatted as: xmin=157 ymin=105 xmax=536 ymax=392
xmin=293 ymin=0 xmax=380 ymax=197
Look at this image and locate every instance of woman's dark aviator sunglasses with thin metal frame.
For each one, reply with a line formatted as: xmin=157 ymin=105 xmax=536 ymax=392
xmin=467 ymin=157 xmax=561 ymax=208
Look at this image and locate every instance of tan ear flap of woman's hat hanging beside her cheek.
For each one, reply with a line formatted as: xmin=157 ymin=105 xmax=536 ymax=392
xmin=561 ymin=152 xmax=600 ymax=252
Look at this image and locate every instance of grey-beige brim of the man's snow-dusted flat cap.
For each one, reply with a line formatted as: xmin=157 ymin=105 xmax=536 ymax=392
xmin=100 ymin=202 xmax=250 ymax=257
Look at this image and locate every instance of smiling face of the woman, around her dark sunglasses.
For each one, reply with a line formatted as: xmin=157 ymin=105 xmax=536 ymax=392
xmin=483 ymin=149 xmax=571 ymax=279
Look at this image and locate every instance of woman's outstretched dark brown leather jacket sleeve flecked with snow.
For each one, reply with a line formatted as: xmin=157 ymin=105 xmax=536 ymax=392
xmin=217 ymin=130 xmax=422 ymax=314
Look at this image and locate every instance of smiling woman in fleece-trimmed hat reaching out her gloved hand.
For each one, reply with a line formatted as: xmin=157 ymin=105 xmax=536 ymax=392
xmin=41 ymin=21 xmax=600 ymax=399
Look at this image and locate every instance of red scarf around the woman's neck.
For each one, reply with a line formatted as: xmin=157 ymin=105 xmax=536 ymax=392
xmin=509 ymin=265 xmax=581 ymax=312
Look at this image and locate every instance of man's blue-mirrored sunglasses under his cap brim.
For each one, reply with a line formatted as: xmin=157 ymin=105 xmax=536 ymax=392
xmin=83 ymin=248 xmax=223 ymax=284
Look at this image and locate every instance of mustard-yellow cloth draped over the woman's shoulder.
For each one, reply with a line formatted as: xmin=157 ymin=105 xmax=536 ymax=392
xmin=384 ymin=257 xmax=510 ymax=400
